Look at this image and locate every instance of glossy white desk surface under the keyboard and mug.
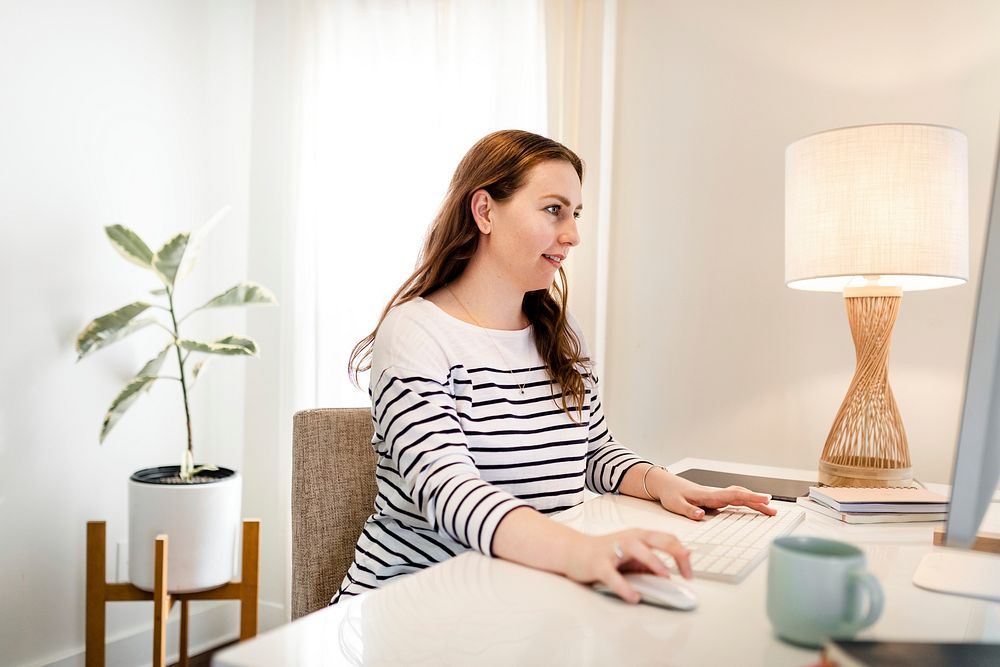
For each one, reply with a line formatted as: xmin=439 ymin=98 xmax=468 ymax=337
xmin=212 ymin=459 xmax=1000 ymax=667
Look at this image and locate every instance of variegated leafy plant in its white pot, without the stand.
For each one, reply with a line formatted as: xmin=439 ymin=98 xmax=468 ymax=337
xmin=76 ymin=209 xmax=277 ymax=593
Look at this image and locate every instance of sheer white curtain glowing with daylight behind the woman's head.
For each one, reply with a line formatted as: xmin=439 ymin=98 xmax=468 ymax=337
xmin=285 ymin=0 xmax=547 ymax=407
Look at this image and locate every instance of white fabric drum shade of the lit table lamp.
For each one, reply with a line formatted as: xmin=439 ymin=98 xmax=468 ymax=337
xmin=785 ymin=124 xmax=969 ymax=292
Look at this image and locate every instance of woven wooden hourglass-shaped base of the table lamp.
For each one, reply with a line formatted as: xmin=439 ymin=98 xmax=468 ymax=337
xmin=819 ymin=287 xmax=914 ymax=487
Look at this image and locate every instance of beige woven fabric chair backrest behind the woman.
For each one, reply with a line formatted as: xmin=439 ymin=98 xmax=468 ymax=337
xmin=292 ymin=408 xmax=376 ymax=619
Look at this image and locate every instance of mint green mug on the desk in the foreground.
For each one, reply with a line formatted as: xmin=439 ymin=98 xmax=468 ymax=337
xmin=767 ymin=535 xmax=884 ymax=647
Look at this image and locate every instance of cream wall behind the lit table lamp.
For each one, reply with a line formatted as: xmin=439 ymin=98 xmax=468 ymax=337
xmin=604 ymin=0 xmax=1000 ymax=481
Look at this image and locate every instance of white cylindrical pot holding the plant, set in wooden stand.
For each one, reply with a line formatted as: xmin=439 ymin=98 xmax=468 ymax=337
xmin=128 ymin=466 xmax=243 ymax=593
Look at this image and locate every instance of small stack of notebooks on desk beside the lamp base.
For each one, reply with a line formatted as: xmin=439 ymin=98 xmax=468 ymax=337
xmin=797 ymin=486 xmax=948 ymax=523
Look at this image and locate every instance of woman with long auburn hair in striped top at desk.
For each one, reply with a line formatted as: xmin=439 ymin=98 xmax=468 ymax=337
xmin=333 ymin=130 xmax=775 ymax=603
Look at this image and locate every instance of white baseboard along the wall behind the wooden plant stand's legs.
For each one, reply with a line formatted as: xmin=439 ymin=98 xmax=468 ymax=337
xmin=34 ymin=601 xmax=287 ymax=667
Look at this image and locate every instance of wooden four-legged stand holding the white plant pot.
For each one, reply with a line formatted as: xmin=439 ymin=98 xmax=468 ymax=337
xmin=86 ymin=519 xmax=260 ymax=667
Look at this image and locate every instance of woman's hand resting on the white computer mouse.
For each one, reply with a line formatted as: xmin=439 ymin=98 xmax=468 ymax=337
xmin=563 ymin=528 xmax=691 ymax=604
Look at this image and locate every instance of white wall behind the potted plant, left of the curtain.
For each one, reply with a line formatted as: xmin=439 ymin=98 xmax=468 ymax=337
xmin=0 ymin=0 xmax=256 ymax=665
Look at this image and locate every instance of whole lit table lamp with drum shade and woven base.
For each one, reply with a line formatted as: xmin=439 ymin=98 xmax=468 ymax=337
xmin=785 ymin=124 xmax=969 ymax=487
